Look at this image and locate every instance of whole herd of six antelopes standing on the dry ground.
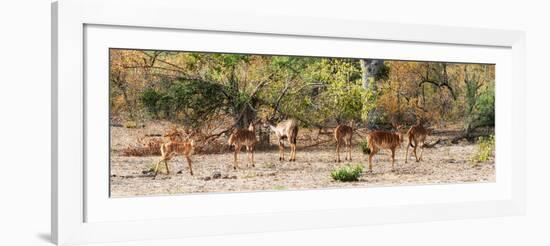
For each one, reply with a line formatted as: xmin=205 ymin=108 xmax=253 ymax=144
xmin=154 ymin=119 xmax=429 ymax=177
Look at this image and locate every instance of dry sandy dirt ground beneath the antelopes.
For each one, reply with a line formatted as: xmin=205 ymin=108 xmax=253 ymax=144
xmin=110 ymin=125 xmax=495 ymax=197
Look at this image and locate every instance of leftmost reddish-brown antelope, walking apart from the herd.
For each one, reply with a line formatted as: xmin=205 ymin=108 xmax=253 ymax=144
xmin=155 ymin=131 xmax=195 ymax=177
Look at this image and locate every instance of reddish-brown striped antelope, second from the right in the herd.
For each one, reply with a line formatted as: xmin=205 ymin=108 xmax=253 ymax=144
xmin=367 ymin=126 xmax=403 ymax=172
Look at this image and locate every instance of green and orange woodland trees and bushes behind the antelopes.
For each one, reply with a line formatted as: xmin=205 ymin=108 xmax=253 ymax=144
xmin=110 ymin=49 xmax=495 ymax=141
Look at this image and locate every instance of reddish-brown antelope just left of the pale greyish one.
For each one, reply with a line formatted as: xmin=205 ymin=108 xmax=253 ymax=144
xmin=228 ymin=123 xmax=257 ymax=170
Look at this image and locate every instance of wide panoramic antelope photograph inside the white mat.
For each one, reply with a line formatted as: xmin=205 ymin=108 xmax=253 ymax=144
xmin=109 ymin=48 xmax=495 ymax=197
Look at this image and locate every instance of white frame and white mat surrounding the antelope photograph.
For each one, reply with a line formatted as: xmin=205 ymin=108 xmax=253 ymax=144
xmin=52 ymin=0 xmax=526 ymax=245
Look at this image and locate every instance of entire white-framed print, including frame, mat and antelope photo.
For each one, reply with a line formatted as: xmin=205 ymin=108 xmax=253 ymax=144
xmin=52 ymin=0 xmax=525 ymax=244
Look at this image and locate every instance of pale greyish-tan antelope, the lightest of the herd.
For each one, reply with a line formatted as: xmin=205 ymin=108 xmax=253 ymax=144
xmin=264 ymin=119 xmax=298 ymax=161
